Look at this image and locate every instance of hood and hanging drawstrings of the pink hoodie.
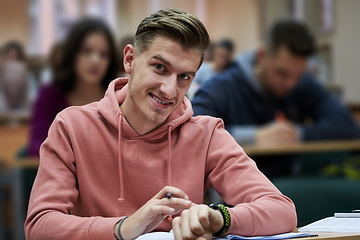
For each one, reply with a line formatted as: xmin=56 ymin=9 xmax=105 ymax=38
xmin=97 ymin=78 xmax=193 ymax=202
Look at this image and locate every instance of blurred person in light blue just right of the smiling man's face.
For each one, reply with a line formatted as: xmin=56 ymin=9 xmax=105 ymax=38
xmin=188 ymin=39 xmax=234 ymax=100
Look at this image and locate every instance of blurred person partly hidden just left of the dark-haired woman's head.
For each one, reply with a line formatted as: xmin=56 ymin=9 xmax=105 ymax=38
xmin=40 ymin=42 xmax=64 ymax=85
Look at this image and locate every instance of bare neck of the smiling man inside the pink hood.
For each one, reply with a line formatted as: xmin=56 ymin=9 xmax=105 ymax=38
xmin=120 ymin=95 xmax=161 ymax=135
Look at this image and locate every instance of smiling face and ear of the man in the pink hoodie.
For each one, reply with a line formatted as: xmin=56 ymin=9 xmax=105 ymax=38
xmin=124 ymin=37 xmax=201 ymax=125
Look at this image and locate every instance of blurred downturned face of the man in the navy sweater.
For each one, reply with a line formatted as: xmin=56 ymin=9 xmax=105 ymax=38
xmin=260 ymin=47 xmax=307 ymax=98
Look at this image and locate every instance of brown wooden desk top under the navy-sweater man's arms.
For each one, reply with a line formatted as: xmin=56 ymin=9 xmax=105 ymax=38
xmin=243 ymin=139 xmax=360 ymax=157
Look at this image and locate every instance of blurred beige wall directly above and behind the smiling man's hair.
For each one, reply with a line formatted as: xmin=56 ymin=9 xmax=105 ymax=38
xmin=117 ymin=0 xmax=260 ymax=51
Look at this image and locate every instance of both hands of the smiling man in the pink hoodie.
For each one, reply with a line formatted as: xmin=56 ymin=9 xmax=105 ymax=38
xmin=114 ymin=186 xmax=224 ymax=240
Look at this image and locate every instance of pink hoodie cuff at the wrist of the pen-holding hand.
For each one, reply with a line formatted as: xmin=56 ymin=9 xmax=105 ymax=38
xmin=88 ymin=217 xmax=124 ymax=240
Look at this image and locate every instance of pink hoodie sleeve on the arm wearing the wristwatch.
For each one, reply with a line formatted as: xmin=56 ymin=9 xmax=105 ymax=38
xmin=206 ymin=119 xmax=297 ymax=236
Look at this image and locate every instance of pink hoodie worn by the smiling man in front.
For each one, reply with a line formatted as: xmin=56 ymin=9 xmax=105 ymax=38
xmin=25 ymin=79 xmax=296 ymax=240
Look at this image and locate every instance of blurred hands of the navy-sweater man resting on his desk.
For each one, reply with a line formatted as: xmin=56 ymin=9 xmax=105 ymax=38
xmin=256 ymin=121 xmax=299 ymax=145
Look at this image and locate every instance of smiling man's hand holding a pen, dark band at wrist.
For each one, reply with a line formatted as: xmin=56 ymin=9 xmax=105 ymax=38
xmin=114 ymin=187 xmax=191 ymax=240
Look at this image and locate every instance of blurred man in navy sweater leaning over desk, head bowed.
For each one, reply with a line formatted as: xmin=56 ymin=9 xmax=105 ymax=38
xmin=192 ymin=20 xmax=359 ymax=177
